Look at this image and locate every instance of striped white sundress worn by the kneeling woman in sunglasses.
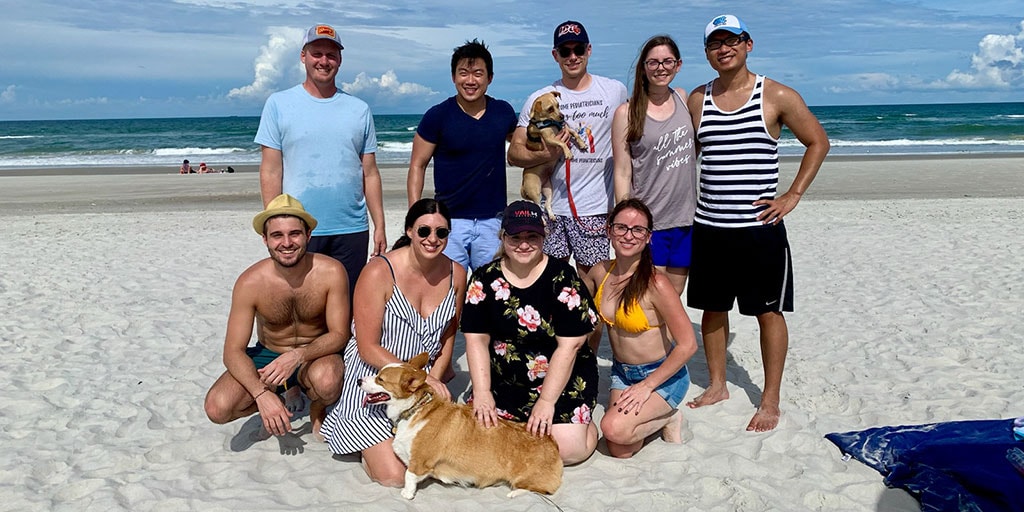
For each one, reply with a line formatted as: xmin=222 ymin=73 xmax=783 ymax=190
xmin=321 ymin=256 xmax=456 ymax=454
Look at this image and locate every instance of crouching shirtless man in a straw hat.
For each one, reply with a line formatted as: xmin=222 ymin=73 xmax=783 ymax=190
xmin=205 ymin=194 xmax=351 ymax=437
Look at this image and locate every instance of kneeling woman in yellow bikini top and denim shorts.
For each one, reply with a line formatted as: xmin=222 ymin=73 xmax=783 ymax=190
xmin=584 ymin=199 xmax=697 ymax=458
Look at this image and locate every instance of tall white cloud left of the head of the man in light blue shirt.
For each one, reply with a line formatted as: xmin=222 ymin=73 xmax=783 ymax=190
xmin=227 ymin=27 xmax=302 ymax=100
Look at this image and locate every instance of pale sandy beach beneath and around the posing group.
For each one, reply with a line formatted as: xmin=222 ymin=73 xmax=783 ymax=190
xmin=0 ymin=156 xmax=1024 ymax=512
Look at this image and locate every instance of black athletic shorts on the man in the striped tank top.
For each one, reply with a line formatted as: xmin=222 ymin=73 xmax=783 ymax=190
xmin=686 ymin=222 xmax=793 ymax=316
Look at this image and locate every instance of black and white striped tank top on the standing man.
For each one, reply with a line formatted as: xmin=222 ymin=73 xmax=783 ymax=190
xmin=694 ymin=75 xmax=778 ymax=227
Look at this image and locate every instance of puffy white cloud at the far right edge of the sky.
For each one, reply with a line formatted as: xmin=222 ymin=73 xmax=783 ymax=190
xmin=940 ymin=20 xmax=1024 ymax=89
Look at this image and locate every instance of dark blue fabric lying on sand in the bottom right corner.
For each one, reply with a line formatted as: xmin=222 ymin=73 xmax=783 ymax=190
xmin=825 ymin=420 xmax=1024 ymax=512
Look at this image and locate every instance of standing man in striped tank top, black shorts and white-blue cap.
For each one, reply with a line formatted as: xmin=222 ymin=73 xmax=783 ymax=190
xmin=686 ymin=14 xmax=828 ymax=432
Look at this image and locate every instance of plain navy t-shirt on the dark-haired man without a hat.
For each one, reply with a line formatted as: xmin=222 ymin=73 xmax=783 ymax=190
xmin=416 ymin=96 xmax=517 ymax=219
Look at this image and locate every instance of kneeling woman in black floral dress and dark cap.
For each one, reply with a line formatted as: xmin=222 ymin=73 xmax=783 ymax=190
xmin=462 ymin=201 xmax=598 ymax=464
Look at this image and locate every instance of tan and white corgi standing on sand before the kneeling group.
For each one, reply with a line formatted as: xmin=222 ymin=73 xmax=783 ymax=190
xmin=359 ymin=352 xmax=562 ymax=500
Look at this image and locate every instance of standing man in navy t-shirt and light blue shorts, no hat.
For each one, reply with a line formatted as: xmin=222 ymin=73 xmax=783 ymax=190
xmin=407 ymin=39 xmax=517 ymax=269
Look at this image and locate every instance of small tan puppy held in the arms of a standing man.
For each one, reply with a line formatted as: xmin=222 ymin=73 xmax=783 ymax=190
xmin=519 ymin=91 xmax=587 ymax=218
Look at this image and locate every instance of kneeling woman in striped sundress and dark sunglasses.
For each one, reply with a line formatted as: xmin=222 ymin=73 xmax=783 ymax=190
xmin=321 ymin=199 xmax=466 ymax=487
